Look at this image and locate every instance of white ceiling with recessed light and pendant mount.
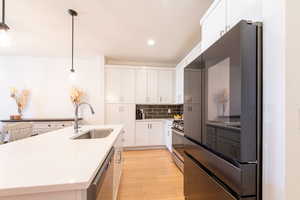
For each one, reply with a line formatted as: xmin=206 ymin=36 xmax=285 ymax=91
xmin=0 ymin=0 xmax=212 ymax=65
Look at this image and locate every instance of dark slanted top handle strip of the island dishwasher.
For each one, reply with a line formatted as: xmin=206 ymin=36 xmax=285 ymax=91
xmin=87 ymin=148 xmax=114 ymax=200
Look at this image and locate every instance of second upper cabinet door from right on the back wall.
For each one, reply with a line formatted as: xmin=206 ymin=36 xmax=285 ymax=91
xmin=146 ymin=70 xmax=158 ymax=103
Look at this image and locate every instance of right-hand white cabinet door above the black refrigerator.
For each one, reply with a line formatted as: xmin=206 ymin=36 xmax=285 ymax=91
xmin=227 ymin=0 xmax=261 ymax=31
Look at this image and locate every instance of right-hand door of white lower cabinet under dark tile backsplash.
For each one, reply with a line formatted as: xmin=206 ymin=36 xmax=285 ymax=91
xmin=149 ymin=122 xmax=165 ymax=146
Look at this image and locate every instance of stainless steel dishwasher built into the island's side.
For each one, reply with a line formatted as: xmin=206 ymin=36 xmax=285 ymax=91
xmin=87 ymin=148 xmax=114 ymax=200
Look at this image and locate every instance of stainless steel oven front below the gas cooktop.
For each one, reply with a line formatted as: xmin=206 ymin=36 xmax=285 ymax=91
xmin=172 ymin=128 xmax=184 ymax=172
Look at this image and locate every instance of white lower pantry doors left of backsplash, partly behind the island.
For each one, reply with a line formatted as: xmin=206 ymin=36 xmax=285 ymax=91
xmin=105 ymin=104 xmax=135 ymax=147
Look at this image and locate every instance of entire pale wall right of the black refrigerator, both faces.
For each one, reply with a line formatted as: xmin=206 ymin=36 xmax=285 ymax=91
xmin=263 ymin=0 xmax=300 ymax=200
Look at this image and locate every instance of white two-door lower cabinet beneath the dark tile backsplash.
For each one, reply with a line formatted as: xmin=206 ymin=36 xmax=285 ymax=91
xmin=135 ymin=122 xmax=165 ymax=146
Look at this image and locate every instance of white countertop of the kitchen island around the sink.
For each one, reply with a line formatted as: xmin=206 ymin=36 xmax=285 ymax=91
xmin=0 ymin=125 xmax=123 ymax=196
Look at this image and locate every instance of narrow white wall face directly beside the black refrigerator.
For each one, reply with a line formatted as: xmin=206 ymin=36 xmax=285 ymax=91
xmin=262 ymin=0 xmax=286 ymax=200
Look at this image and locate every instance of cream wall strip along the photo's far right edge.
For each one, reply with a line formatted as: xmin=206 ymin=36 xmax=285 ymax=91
xmin=285 ymin=0 xmax=300 ymax=200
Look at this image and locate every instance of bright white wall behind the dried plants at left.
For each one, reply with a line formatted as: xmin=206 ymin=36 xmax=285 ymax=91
xmin=0 ymin=56 xmax=104 ymax=124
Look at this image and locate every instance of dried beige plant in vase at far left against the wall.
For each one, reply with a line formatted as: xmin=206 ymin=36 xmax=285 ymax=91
xmin=10 ymin=88 xmax=29 ymax=120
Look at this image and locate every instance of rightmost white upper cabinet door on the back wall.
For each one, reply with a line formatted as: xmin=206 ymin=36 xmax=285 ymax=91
xmin=158 ymin=70 xmax=175 ymax=104
